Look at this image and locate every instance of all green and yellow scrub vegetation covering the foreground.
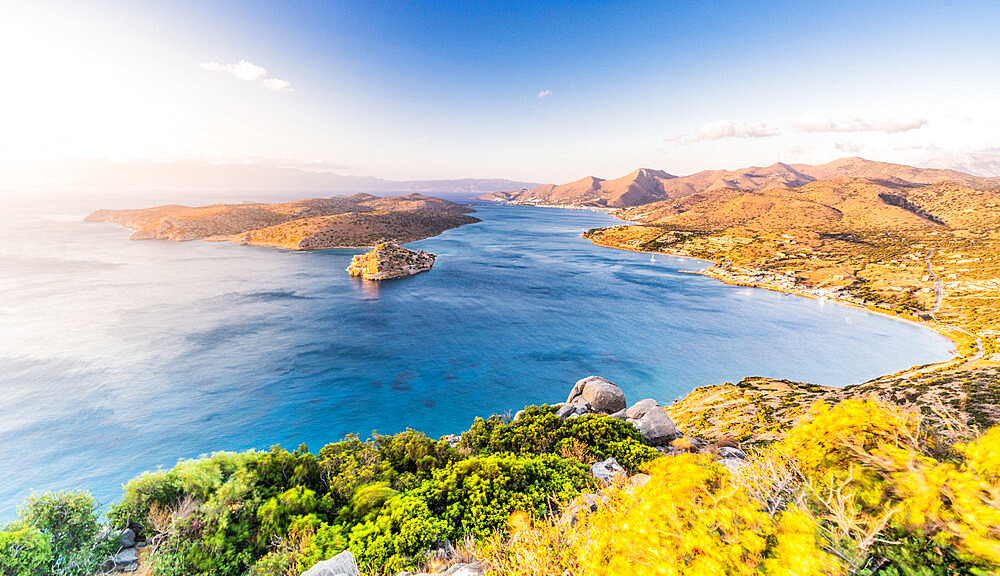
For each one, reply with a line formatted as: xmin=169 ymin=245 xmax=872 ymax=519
xmin=0 ymin=399 xmax=1000 ymax=576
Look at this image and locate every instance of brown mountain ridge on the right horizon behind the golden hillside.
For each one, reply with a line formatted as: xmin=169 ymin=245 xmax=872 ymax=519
xmin=478 ymin=158 xmax=1000 ymax=208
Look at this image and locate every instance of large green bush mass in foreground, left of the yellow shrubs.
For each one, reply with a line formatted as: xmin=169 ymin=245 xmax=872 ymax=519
xmin=101 ymin=406 xmax=657 ymax=576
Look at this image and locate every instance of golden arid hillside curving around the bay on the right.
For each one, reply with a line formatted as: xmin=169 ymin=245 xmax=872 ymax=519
xmin=585 ymin=170 xmax=1000 ymax=432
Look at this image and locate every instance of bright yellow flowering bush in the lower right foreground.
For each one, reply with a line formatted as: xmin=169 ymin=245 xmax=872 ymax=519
xmin=481 ymin=400 xmax=1000 ymax=576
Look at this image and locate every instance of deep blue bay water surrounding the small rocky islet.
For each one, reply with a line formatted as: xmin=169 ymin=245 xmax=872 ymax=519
xmin=0 ymin=192 xmax=951 ymax=519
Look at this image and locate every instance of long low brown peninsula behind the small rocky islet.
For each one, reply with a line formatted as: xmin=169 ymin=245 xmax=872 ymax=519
xmin=85 ymin=193 xmax=479 ymax=250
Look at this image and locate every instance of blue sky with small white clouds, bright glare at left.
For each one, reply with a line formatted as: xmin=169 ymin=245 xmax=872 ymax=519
xmin=0 ymin=0 xmax=1000 ymax=182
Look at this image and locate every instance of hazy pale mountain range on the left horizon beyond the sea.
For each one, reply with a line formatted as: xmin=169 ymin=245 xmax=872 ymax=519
xmin=0 ymin=159 xmax=536 ymax=196
